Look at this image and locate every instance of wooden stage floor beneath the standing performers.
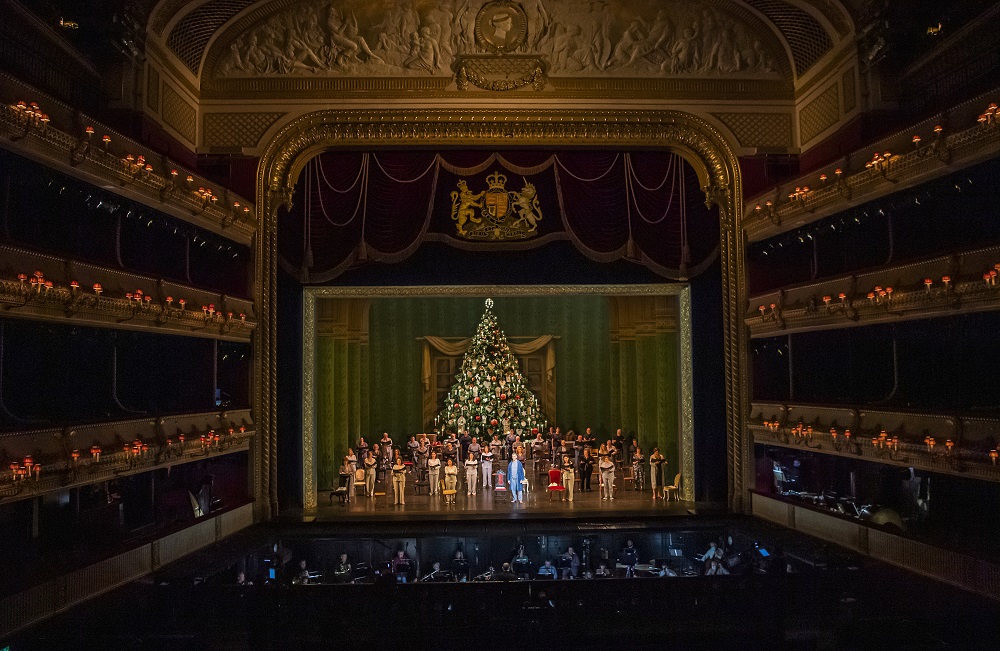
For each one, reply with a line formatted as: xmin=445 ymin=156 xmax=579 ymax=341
xmin=281 ymin=476 xmax=704 ymax=522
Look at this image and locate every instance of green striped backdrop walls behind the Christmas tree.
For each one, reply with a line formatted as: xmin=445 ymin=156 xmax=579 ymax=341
xmin=315 ymin=296 xmax=679 ymax=487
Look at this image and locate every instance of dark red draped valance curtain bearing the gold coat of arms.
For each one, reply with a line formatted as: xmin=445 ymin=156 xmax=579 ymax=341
xmin=279 ymin=151 xmax=719 ymax=283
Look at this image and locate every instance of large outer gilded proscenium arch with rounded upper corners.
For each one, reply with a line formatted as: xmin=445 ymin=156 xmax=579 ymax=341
xmin=253 ymin=109 xmax=752 ymax=519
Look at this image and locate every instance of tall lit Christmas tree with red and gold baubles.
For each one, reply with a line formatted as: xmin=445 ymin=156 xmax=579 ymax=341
xmin=437 ymin=299 xmax=545 ymax=436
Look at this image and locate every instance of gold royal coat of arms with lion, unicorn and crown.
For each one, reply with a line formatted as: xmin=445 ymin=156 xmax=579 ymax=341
xmin=451 ymin=172 xmax=542 ymax=241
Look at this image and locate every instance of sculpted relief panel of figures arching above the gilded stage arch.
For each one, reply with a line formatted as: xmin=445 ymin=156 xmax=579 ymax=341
xmin=203 ymin=0 xmax=790 ymax=80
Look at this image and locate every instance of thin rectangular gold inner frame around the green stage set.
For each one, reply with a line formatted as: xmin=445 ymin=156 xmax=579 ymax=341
xmin=302 ymin=283 xmax=694 ymax=509
